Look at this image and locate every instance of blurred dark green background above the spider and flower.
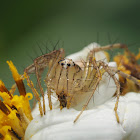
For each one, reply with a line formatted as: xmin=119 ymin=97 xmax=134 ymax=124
xmin=0 ymin=0 xmax=140 ymax=87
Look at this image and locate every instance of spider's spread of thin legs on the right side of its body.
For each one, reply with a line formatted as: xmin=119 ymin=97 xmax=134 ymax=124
xmin=74 ymin=43 xmax=140 ymax=123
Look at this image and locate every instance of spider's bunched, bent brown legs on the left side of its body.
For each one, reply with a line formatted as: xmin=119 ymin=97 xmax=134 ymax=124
xmin=24 ymin=49 xmax=64 ymax=116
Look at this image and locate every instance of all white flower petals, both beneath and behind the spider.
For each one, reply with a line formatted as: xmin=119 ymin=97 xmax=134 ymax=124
xmin=25 ymin=43 xmax=140 ymax=140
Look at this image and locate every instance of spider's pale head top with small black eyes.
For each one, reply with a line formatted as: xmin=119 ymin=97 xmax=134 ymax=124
xmin=58 ymin=59 xmax=75 ymax=69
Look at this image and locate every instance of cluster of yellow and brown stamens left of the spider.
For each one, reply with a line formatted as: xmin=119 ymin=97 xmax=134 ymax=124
xmin=0 ymin=61 xmax=33 ymax=140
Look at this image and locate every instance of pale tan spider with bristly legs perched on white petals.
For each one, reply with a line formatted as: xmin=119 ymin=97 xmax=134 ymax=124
xmin=24 ymin=43 xmax=140 ymax=123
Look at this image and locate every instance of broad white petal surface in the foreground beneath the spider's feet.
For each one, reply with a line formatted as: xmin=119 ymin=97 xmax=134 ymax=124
xmin=25 ymin=93 xmax=140 ymax=140
